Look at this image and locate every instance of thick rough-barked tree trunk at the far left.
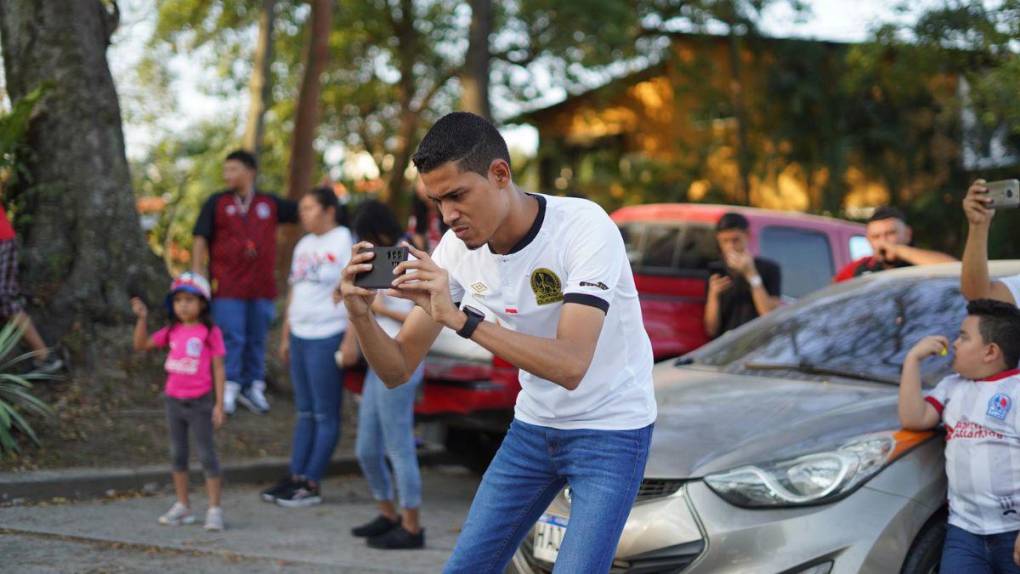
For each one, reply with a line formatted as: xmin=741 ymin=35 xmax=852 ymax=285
xmin=0 ymin=0 xmax=166 ymax=356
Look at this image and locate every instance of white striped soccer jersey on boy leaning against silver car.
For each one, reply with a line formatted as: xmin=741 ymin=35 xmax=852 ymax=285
xmin=925 ymin=369 xmax=1020 ymax=534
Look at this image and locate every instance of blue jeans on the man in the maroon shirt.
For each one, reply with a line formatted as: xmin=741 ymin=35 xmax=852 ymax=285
xmin=212 ymin=298 xmax=276 ymax=388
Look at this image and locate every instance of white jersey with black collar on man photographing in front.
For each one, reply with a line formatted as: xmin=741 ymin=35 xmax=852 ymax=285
xmin=432 ymin=195 xmax=656 ymax=430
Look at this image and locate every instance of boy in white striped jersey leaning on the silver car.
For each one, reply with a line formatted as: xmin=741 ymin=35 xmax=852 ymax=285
xmin=900 ymin=299 xmax=1020 ymax=574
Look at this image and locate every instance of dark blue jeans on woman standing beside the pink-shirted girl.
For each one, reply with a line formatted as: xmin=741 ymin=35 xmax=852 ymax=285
xmin=291 ymin=333 xmax=344 ymax=482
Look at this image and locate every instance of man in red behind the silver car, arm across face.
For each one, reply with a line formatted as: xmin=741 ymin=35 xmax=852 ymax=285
xmin=832 ymin=206 xmax=956 ymax=283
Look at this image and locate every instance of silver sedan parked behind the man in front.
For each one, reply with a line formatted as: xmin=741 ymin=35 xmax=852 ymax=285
xmin=511 ymin=261 xmax=1020 ymax=574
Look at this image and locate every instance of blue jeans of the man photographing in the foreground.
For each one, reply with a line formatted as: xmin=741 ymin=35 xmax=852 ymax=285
xmin=444 ymin=419 xmax=652 ymax=574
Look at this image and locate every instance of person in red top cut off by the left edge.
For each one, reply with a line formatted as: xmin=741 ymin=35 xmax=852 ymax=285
xmin=0 ymin=205 xmax=63 ymax=374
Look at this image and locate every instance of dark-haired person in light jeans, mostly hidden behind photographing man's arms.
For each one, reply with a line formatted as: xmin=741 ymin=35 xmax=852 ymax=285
xmin=341 ymin=201 xmax=425 ymax=550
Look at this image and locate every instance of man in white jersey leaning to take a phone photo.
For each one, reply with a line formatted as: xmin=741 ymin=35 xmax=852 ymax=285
xmin=341 ymin=112 xmax=656 ymax=574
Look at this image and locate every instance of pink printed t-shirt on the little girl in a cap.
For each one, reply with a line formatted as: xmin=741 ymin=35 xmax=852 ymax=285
xmin=152 ymin=323 xmax=226 ymax=399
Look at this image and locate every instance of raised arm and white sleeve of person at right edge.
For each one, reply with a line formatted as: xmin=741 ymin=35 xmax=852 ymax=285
xmin=960 ymin=179 xmax=1020 ymax=305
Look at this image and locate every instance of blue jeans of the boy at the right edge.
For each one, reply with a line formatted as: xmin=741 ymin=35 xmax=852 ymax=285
xmin=938 ymin=524 xmax=1020 ymax=574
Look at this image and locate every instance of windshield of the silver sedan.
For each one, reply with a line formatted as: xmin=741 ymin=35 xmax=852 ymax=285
xmin=681 ymin=276 xmax=966 ymax=386
